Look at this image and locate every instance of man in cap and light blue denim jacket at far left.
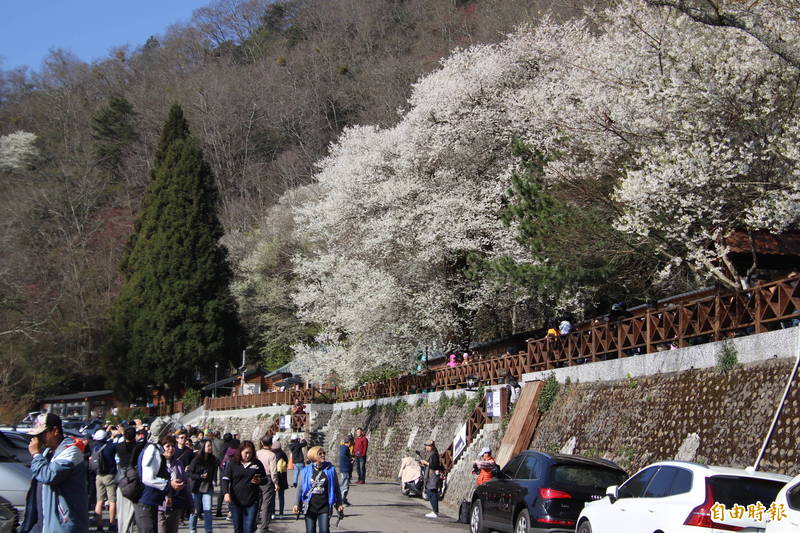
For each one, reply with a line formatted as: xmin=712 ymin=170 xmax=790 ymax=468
xmin=20 ymin=413 xmax=89 ymax=533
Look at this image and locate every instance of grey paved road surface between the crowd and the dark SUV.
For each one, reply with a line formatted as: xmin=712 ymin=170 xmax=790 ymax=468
xmin=181 ymin=481 xmax=469 ymax=533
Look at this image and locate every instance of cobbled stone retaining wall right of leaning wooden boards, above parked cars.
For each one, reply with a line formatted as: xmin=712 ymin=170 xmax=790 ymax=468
xmin=530 ymin=359 xmax=800 ymax=475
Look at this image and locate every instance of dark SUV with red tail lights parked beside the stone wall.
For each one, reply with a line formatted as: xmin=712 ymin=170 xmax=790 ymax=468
xmin=470 ymin=451 xmax=627 ymax=533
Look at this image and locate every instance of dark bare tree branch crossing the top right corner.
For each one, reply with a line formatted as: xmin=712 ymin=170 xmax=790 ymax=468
xmin=647 ymin=0 xmax=800 ymax=70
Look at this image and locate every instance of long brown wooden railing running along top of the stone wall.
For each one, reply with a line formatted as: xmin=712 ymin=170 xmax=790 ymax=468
xmin=206 ymin=277 xmax=800 ymax=409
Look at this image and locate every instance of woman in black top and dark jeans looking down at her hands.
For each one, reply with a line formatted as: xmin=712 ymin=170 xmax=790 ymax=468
xmin=222 ymin=440 xmax=268 ymax=533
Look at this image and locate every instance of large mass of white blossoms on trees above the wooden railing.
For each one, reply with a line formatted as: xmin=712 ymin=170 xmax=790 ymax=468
xmin=284 ymin=0 xmax=800 ymax=383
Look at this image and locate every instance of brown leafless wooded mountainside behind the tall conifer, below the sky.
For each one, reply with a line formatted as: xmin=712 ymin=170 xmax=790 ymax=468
xmin=0 ymin=0 xmax=588 ymax=406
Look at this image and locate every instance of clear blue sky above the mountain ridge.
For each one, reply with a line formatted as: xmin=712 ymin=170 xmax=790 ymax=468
xmin=0 ymin=0 xmax=211 ymax=70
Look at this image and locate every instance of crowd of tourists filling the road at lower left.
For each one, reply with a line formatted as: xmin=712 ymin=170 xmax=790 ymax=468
xmin=20 ymin=413 xmax=382 ymax=533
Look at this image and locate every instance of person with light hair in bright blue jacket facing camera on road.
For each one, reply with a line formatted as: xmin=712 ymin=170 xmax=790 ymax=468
xmin=294 ymin=446 xmax=344 ymax=533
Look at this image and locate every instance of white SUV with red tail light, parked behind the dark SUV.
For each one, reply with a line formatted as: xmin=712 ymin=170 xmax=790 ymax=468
xmin=576 ymin=461 xmax=790 ymax=533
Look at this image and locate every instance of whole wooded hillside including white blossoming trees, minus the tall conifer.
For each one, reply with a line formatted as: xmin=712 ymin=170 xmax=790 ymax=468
xmin=0 ymin=0 xmax=800 ymax=406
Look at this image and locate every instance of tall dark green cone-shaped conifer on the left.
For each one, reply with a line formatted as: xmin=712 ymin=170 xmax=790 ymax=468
xmin=110 ymin=105 xmax=239 ymax=396
